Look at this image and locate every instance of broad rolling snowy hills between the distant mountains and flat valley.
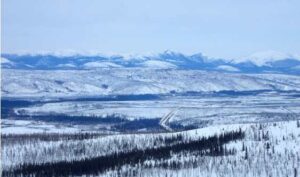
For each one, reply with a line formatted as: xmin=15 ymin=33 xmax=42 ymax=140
xmin=1 ymin=68 xmax=300 ymax=97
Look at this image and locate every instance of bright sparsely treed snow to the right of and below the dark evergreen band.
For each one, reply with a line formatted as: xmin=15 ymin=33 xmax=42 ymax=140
xmin=100 ymin=121 xmax=300 ymax=177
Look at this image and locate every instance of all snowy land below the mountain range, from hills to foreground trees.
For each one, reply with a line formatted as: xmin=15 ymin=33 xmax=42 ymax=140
xmin=1 ymin=67 xmax=300 ymax=177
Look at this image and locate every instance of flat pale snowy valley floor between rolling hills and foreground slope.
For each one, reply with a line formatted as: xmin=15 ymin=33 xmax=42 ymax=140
xmin=2 ymin=92 xmax=300 ymax=132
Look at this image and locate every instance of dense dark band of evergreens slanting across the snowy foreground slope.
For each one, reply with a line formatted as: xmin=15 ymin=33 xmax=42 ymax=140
xmin=2 ymin=130 xmax=245 ymax=177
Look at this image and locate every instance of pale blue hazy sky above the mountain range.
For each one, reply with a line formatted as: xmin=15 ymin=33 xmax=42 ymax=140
xmin=1 ymin=0 xmax=300 ymax=58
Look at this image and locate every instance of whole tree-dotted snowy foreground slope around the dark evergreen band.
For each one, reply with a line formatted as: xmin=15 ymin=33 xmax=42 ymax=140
xmin=1 ymin=121 xmax=300 ymax=177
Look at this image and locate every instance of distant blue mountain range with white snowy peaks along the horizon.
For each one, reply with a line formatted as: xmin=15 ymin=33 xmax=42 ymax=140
xmin=1 ymin=51 xmax=300 ymax=74
